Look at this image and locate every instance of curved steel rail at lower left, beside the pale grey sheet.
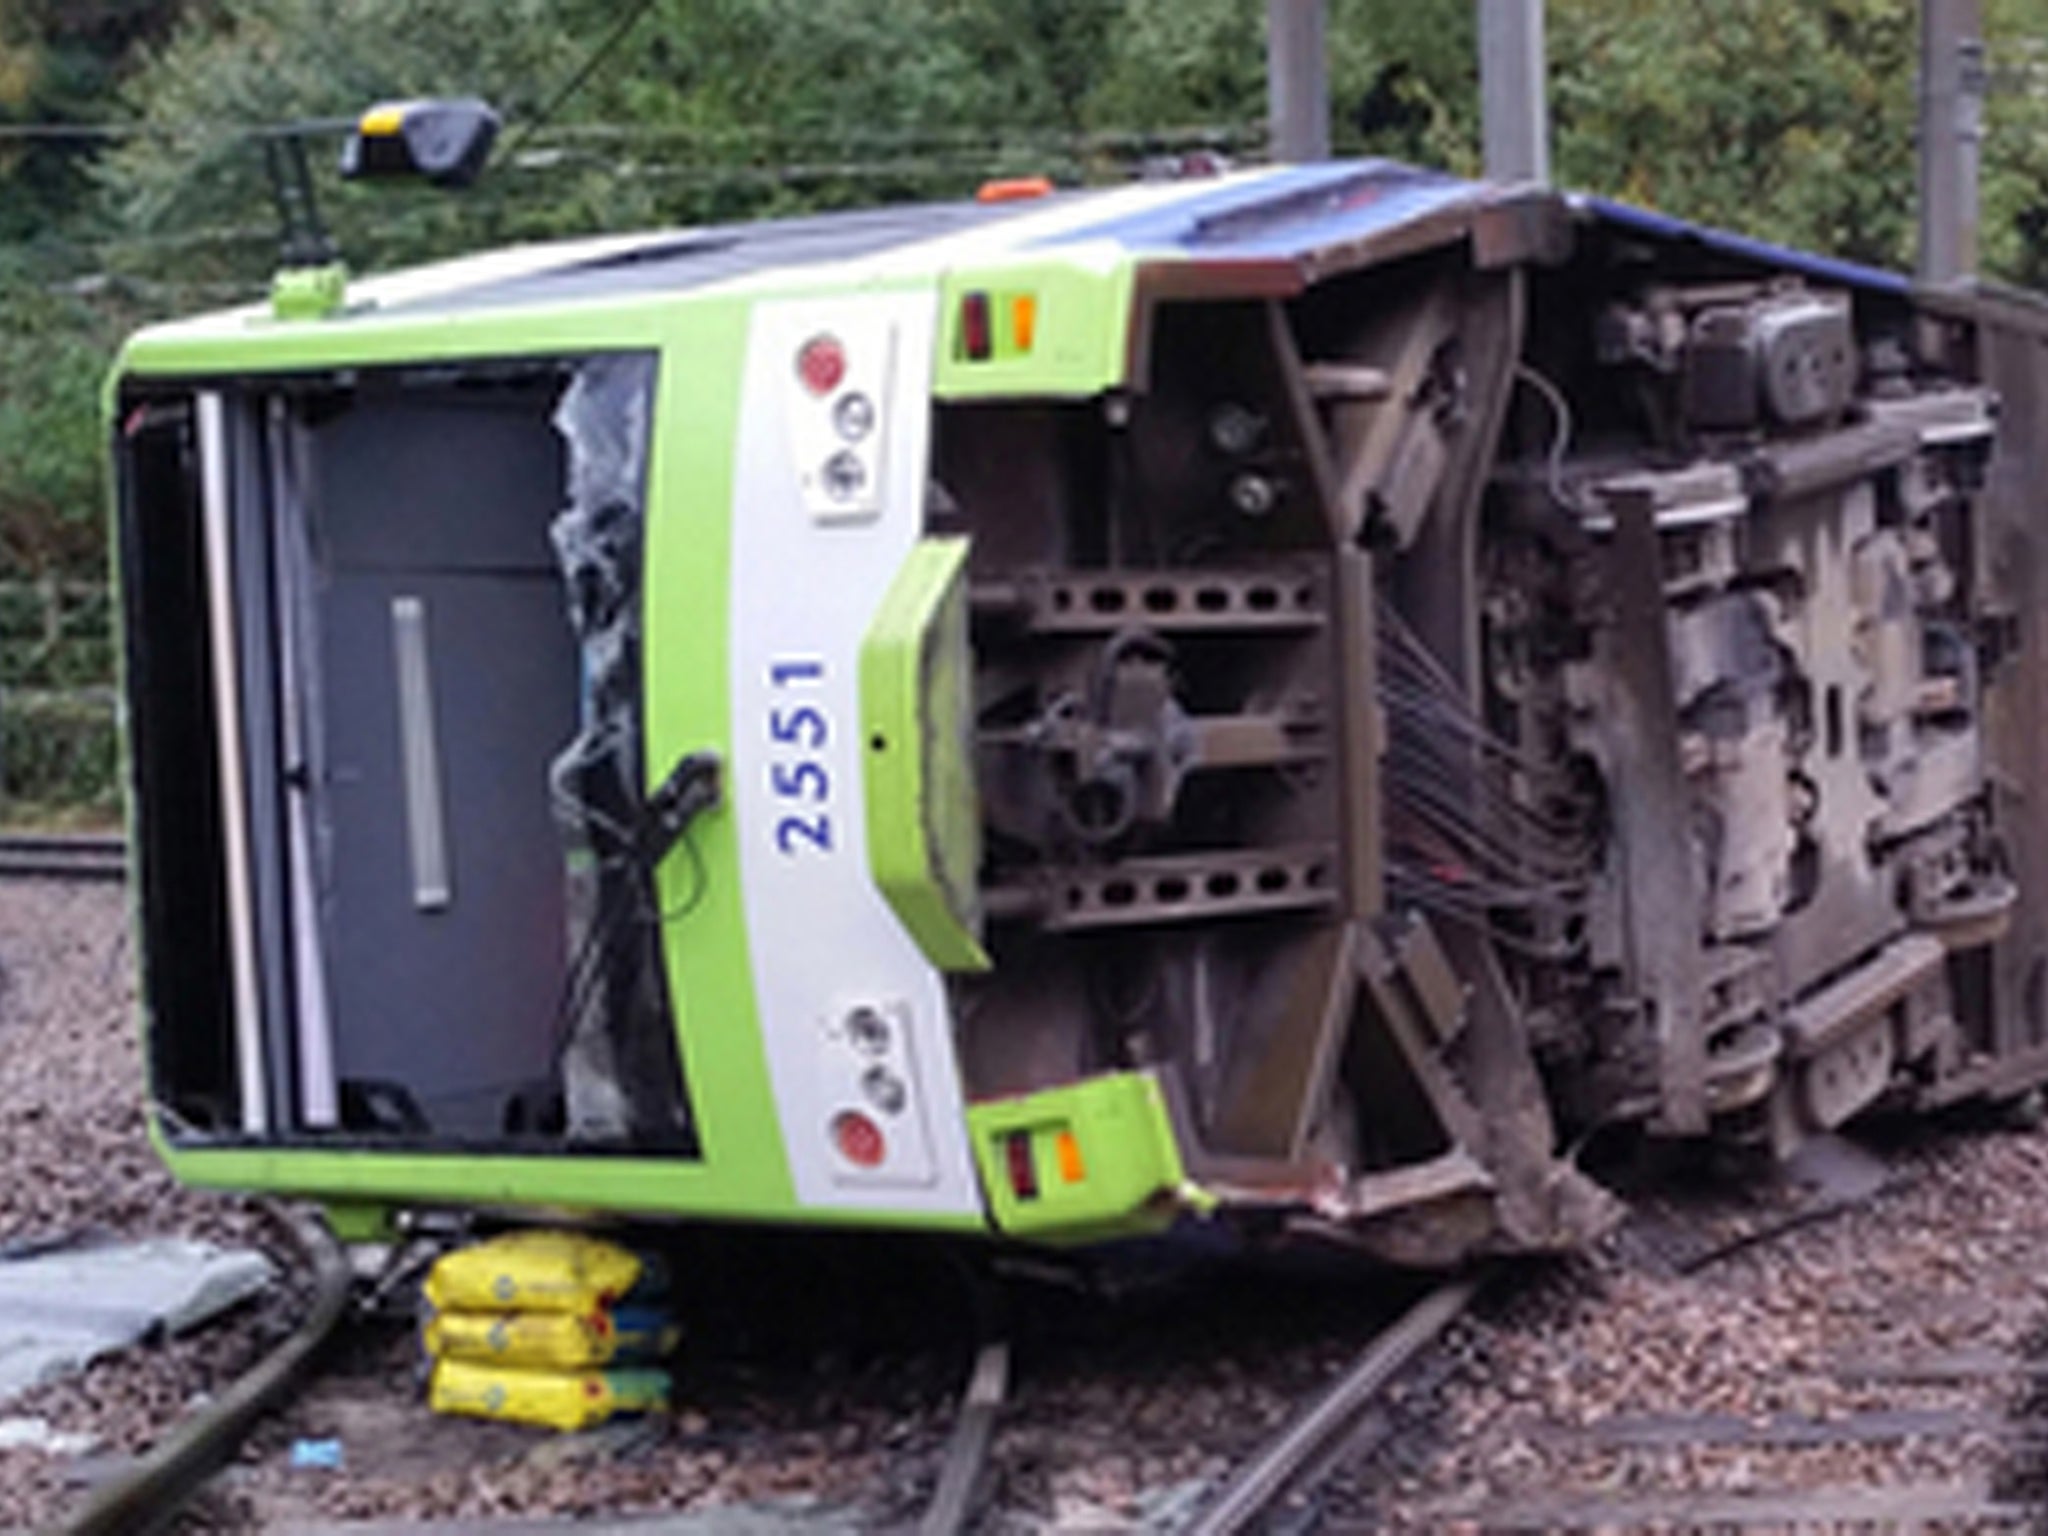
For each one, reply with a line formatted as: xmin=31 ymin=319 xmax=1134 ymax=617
xmin=53 ymin=1210 xmax=354 ymax=1536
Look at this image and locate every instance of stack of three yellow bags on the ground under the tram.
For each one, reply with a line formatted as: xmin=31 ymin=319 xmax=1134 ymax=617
xmin=422 ymin=1231 xmax=678 ymax=1430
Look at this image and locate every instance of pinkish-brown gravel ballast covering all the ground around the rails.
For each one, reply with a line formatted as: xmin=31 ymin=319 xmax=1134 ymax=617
xmin=12 ymin=881 xmax=2048 ymax=1532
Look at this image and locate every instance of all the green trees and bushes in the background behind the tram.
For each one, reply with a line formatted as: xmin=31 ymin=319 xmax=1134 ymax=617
xmin=0 ymin=0 xmax=2048 ymax=831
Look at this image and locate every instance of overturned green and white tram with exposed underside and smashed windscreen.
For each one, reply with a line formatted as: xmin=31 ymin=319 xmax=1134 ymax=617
xmin=111 ymin=162 xmax=2048 ymax=1266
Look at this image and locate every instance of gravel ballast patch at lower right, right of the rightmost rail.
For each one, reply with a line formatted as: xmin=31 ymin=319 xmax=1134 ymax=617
xmin=1331 ymin=1126 xmax=2048 ymax=1532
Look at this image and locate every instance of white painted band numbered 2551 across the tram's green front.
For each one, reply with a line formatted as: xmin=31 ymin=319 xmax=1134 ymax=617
xmin=731 ymin=289 xmax=981 ymax=1214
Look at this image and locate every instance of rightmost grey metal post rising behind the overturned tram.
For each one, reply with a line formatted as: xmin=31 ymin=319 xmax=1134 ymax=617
xmin=1916 ymin=0 xmax=1985 ymax=285
